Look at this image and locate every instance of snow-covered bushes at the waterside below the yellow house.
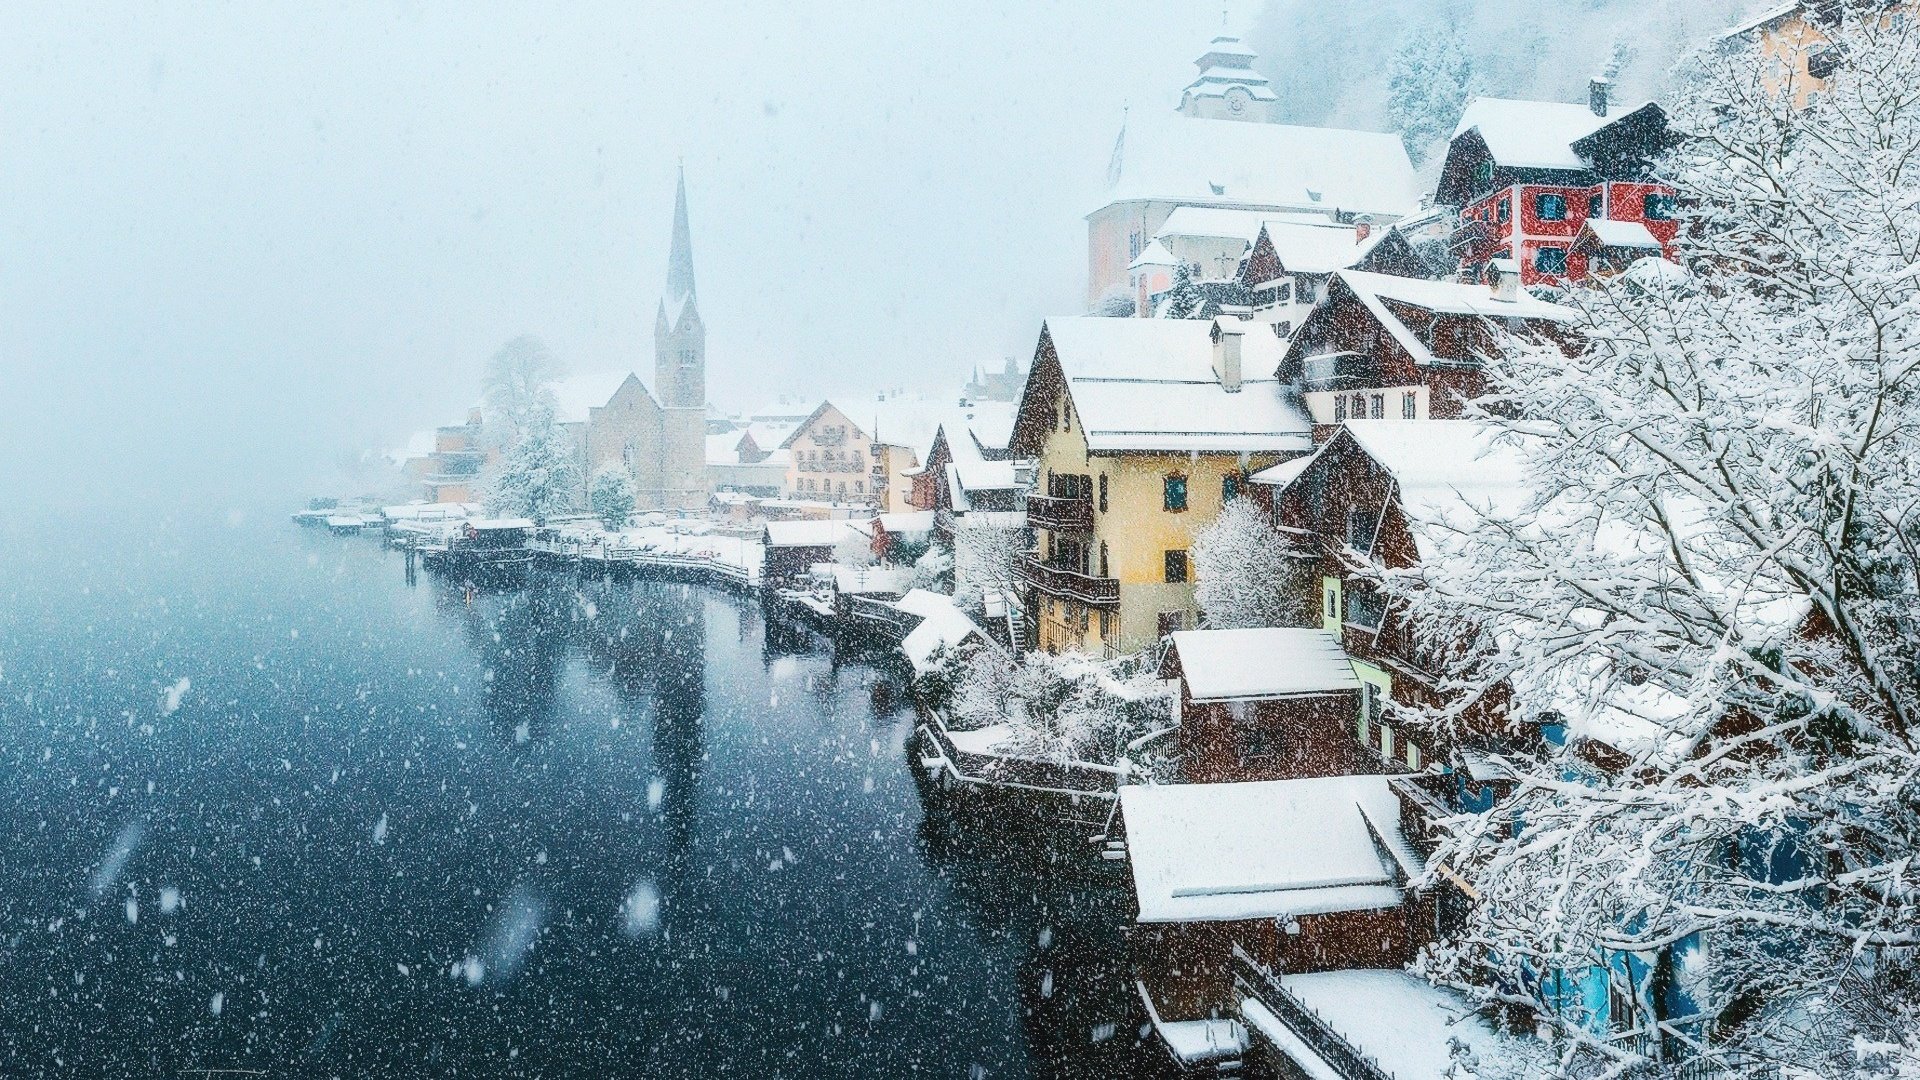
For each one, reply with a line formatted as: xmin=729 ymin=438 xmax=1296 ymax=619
xmin=943 ymin=648 xmax=1171 ymax=763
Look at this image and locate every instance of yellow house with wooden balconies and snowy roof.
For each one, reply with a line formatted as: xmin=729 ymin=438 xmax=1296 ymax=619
xmin=1014 ymin=317 xmax=1313 ymax=655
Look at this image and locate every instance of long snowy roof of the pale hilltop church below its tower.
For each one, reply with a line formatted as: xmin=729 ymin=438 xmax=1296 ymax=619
xmin=1104 ymin=115 xmax=1421 ymax=213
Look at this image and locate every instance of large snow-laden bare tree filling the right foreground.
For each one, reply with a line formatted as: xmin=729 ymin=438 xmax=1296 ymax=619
xmin=1388 ymin=12 xmax=1920 ymax=1078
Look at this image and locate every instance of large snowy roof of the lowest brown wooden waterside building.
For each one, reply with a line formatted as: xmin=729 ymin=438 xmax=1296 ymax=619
xmin=1119 ymin=776 xmax=1421 ymax=922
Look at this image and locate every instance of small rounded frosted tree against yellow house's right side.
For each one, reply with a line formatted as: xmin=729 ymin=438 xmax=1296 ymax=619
xmin=1192 ymin=500 xmax=1309 ymax=630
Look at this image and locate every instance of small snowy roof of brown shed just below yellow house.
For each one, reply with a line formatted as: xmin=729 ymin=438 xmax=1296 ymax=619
xmin=1173 ymin=626 xmax=1359 ymax=701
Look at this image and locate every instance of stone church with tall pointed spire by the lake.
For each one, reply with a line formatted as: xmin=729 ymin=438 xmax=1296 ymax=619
xmin=584 ymin=171 xmax=707 ymax=511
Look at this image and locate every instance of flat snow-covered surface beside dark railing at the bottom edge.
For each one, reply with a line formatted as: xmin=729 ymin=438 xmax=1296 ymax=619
xmin=1281 ymin=969 xmax=1511 ymax=1080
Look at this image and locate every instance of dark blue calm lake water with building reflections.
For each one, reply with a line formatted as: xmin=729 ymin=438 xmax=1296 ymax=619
xmin=0 ymin=515 xmax=1158 ymax=1078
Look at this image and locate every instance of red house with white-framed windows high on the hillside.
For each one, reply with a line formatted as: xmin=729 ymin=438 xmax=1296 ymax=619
xmin=1434 ymin=79 xmax=1678 ymax=284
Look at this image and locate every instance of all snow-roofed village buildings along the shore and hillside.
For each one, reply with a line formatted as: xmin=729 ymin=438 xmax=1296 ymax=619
xmin=341 ymin=4 xmax=1904 ymax=1078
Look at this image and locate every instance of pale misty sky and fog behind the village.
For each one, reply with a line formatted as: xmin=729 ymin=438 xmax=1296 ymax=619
xmin=0 ymin=0 xmax=1753 ymax=515
